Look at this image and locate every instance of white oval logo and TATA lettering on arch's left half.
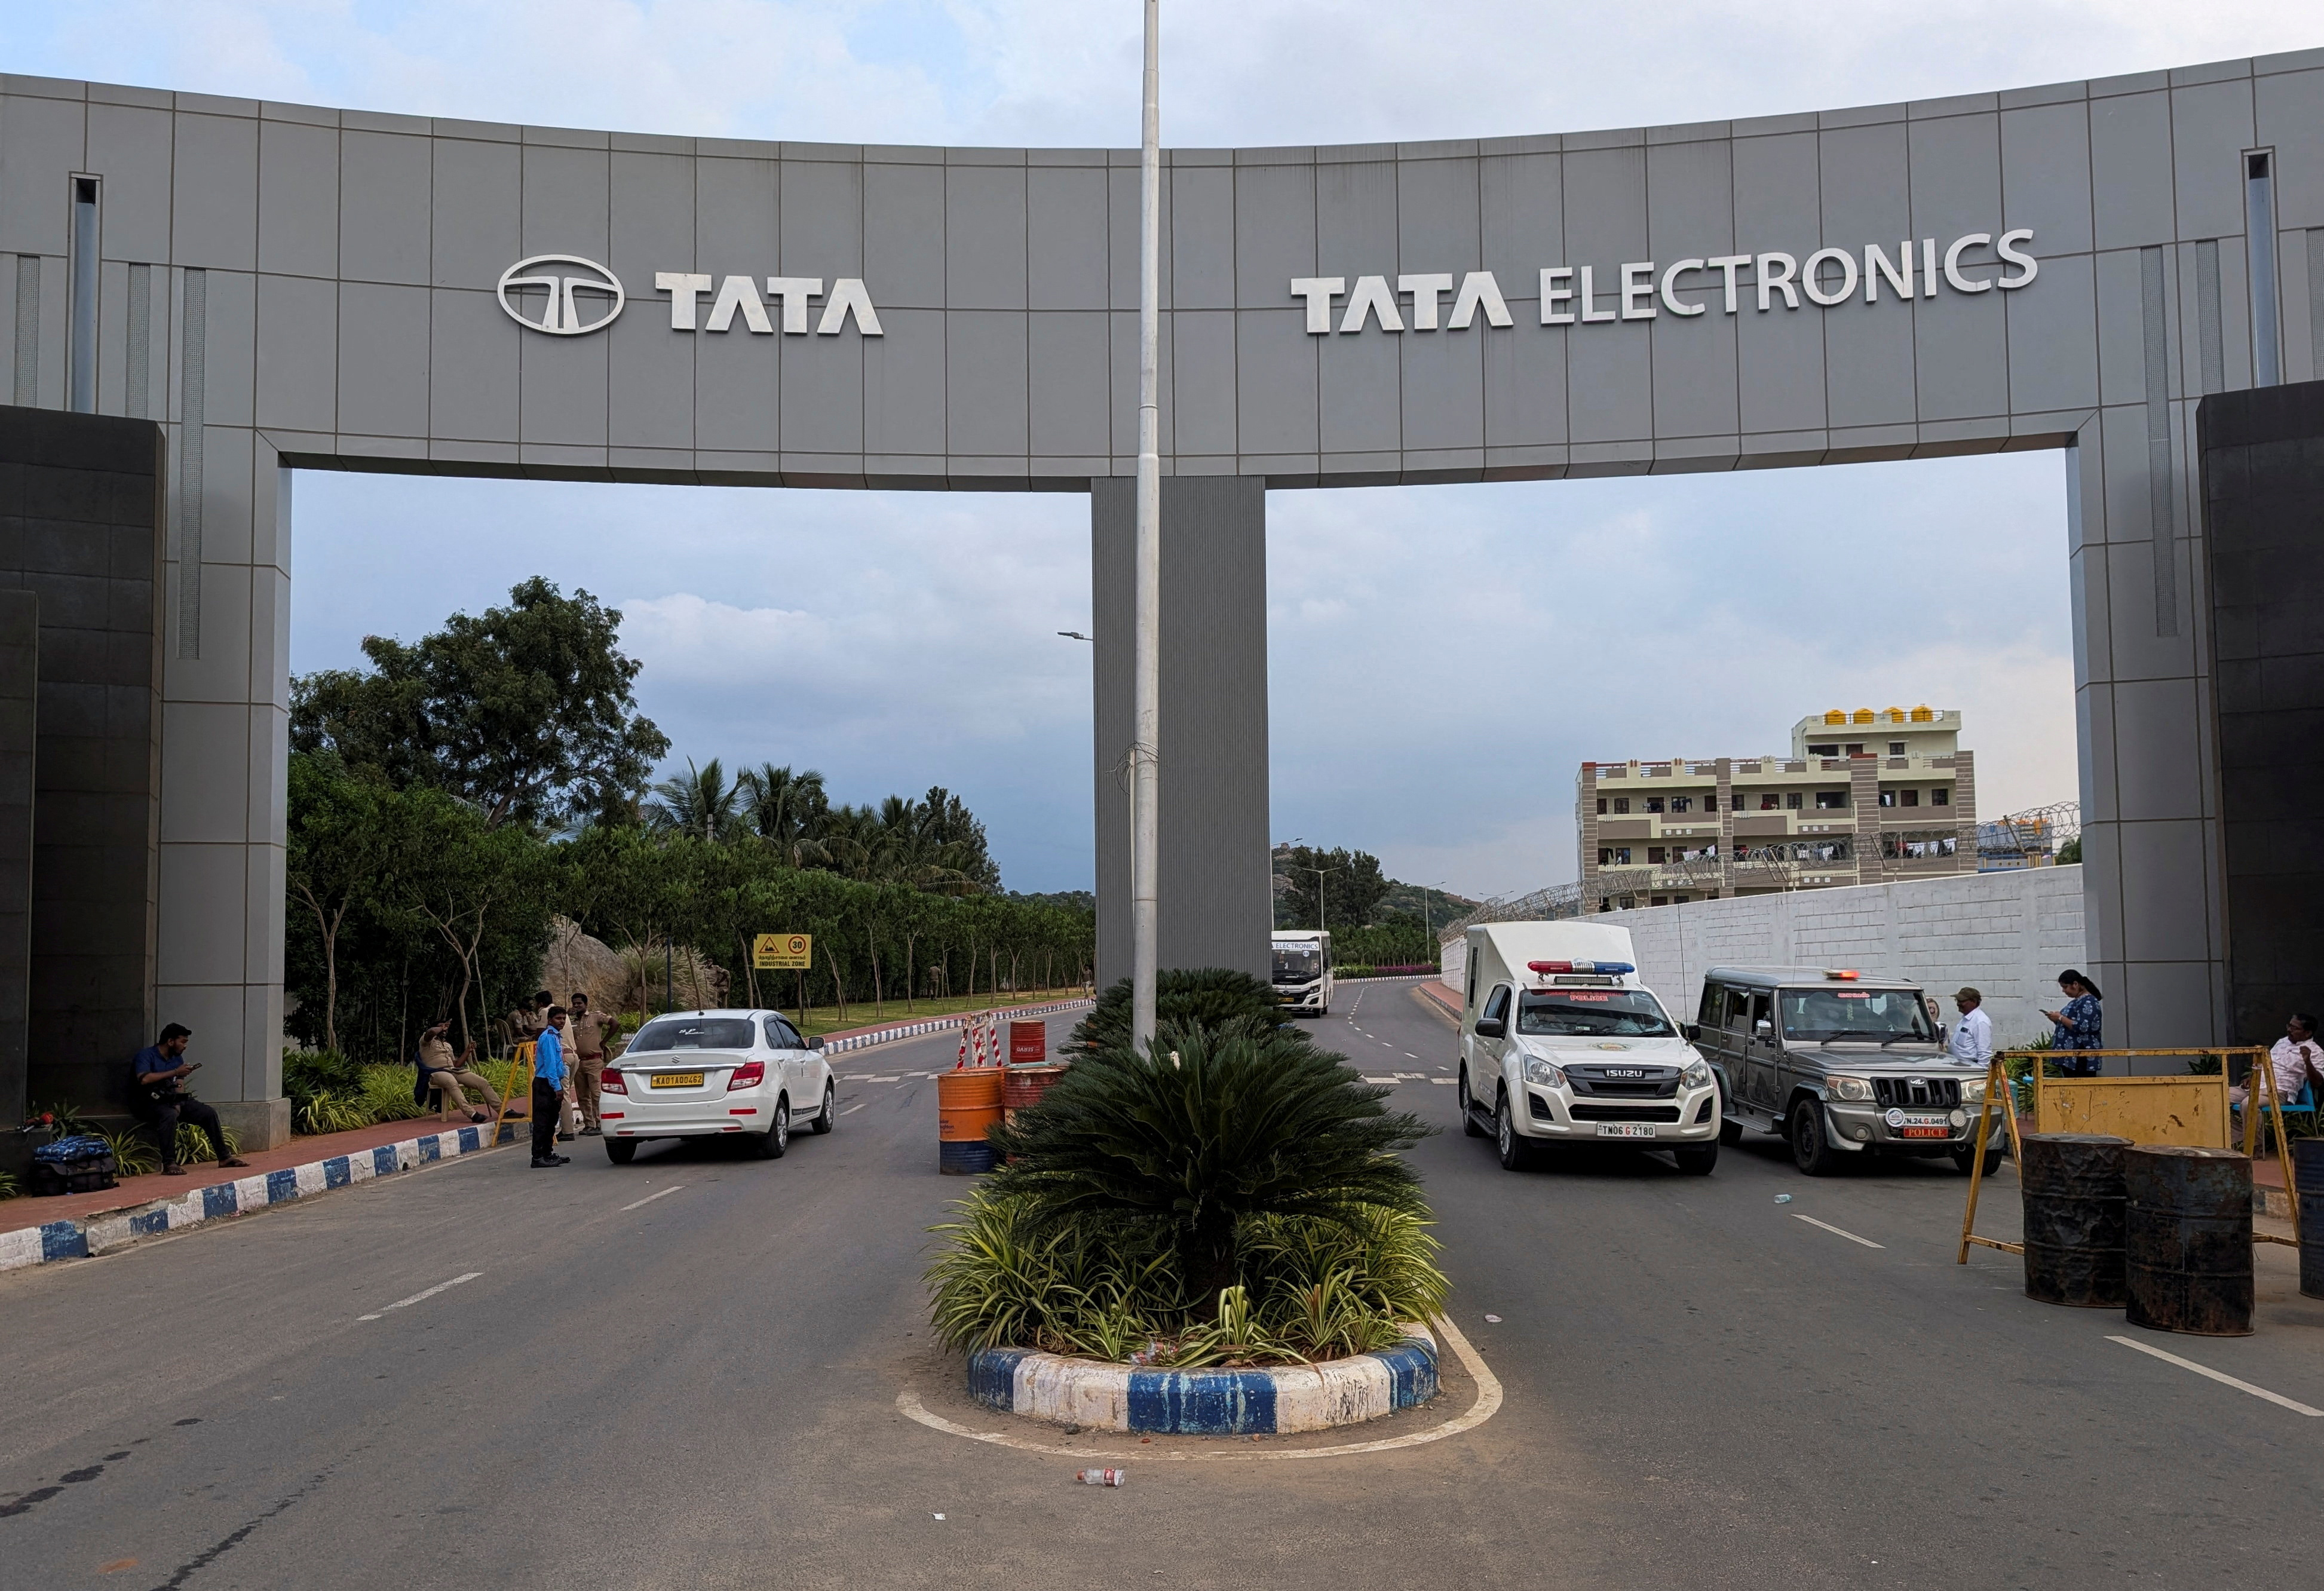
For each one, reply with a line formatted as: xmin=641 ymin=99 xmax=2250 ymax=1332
xmin=499 ymin=253 xmax=881 ymax=337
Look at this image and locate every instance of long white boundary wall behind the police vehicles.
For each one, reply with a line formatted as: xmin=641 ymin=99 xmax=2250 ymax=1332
xmin=1441 ymin=866 xmax=2089 ymax=1045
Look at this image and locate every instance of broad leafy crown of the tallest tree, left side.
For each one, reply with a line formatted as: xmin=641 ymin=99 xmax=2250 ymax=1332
xmin=290 ymin=576 xmax=669 ymax=824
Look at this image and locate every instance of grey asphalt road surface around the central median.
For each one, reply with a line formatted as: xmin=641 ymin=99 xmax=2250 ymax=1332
xmin=0 ymin=982 xmax=2324 ymax=1591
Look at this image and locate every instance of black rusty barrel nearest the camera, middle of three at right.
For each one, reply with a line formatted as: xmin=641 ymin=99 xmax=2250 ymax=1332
xmin=2122 ymin=1143 xmax=2252 ymax=1338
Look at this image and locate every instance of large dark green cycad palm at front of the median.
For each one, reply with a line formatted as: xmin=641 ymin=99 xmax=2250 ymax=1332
xmin=990 ymin=1020 xmax=1431 ymax=1310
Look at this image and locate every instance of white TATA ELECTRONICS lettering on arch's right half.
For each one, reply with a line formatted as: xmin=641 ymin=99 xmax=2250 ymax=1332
xmin=1292 ymin=228 xmax=2040 ymax=337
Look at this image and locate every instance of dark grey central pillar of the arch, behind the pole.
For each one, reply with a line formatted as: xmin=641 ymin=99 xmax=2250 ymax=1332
xmin=1090 ymin=476 xmax=1274 ymax=987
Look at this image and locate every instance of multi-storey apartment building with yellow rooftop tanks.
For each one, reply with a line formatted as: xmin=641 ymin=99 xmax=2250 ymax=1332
xmin=1574 ymin=706 xmax=1977 ymax=911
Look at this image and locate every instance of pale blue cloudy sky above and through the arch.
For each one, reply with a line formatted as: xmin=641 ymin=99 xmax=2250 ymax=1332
xmin=0 ymin=0 xmax=2324 ymax=894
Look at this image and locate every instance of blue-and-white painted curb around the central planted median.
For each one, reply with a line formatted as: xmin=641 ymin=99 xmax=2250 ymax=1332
xmin=969 ymin=1326 xmax=1436 ymax=1436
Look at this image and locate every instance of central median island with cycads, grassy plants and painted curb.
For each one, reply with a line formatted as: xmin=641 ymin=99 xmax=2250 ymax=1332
xmin=927 ymin=968 xmax=1448 ymax=1436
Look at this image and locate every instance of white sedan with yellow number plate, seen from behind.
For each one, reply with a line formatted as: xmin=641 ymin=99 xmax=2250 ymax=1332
xmin=597 ymin=1010 xmax=839 ymax=1166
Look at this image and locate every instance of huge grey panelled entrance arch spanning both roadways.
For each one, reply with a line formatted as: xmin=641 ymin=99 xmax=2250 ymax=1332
xmin=0 ymin=51 xmax=2324 ymax=1133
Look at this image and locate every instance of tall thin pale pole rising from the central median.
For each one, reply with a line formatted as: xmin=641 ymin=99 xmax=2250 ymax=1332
xmin=1130 ymin=0 xmax=1162 ymax=1050
